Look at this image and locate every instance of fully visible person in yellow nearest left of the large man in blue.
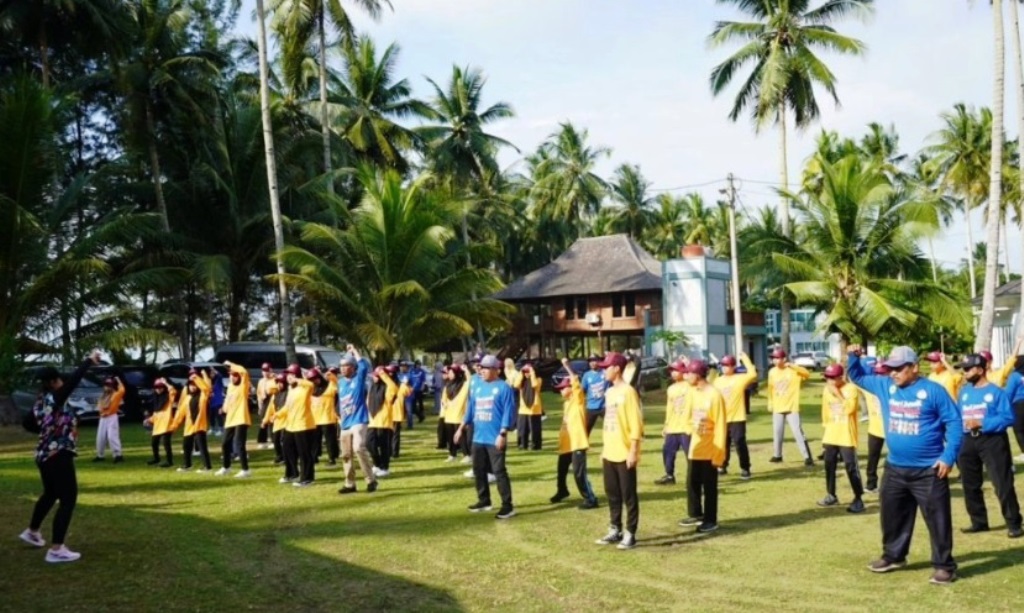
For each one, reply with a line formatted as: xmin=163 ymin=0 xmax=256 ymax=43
xmin=818 ymin=364 xmax=864 ymax=513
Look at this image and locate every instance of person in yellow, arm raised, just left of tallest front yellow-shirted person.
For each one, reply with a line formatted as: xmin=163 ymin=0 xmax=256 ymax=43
xmin=551 ymin=358 xmax=597 ymax=510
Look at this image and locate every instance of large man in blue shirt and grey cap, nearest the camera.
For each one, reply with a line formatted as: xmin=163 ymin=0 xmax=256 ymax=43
xmin=848 ymin=345 xmax=964 ymax=585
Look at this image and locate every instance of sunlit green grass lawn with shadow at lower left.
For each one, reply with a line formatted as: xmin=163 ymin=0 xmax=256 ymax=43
xmin=0 ymin=384 xmax=1024 ymax=611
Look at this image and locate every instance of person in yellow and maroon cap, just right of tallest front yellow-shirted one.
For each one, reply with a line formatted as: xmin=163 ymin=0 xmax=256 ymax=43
xmin=679 ymin=359 xmax=729 ymax=534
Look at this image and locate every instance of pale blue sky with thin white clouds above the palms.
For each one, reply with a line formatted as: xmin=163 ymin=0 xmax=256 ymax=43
xmin=239 ymin=0 xmax=1024 ymax=271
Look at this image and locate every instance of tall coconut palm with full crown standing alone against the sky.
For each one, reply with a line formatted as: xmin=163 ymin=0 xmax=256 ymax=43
xmin=708 ymin=0 xmax=873 ymax=347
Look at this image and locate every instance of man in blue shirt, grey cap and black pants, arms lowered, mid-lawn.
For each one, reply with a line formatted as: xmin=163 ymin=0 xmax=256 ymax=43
xmin=455 ymin=355 xmax=517 ymax=519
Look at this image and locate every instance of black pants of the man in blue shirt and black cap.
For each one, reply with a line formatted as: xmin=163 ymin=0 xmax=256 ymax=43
xmin=957 ymin=432 xmax=1021 ymax=528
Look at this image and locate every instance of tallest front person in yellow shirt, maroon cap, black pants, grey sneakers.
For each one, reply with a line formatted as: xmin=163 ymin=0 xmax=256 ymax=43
xmin=596 ymin=351 xmax=643 ymax=550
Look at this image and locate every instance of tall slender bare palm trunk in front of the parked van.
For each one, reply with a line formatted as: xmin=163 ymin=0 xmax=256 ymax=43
xmin=256 ymin=0 xmax=296 ymax=364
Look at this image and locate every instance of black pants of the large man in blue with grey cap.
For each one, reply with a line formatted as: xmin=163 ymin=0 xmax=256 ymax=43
xmin=879 ymin=465 xmax=956 ymax=572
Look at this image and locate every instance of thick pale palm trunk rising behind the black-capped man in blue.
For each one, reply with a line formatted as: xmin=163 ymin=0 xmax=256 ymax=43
xmin=974 ymin=0 xmax=1017 ymax=351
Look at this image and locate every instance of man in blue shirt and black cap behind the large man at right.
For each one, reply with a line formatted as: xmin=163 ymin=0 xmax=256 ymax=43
xmin=957 ymin=354 xmax=1024 ymax=538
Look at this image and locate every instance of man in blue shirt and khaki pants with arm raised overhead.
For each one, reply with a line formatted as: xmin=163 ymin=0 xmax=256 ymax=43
xmin=338 ymin=345 xmax=377 ymax=494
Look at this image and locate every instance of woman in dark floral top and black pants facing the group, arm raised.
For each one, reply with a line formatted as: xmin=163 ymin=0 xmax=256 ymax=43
xmin=19 ymin=351 xmax=99 ymax=563
